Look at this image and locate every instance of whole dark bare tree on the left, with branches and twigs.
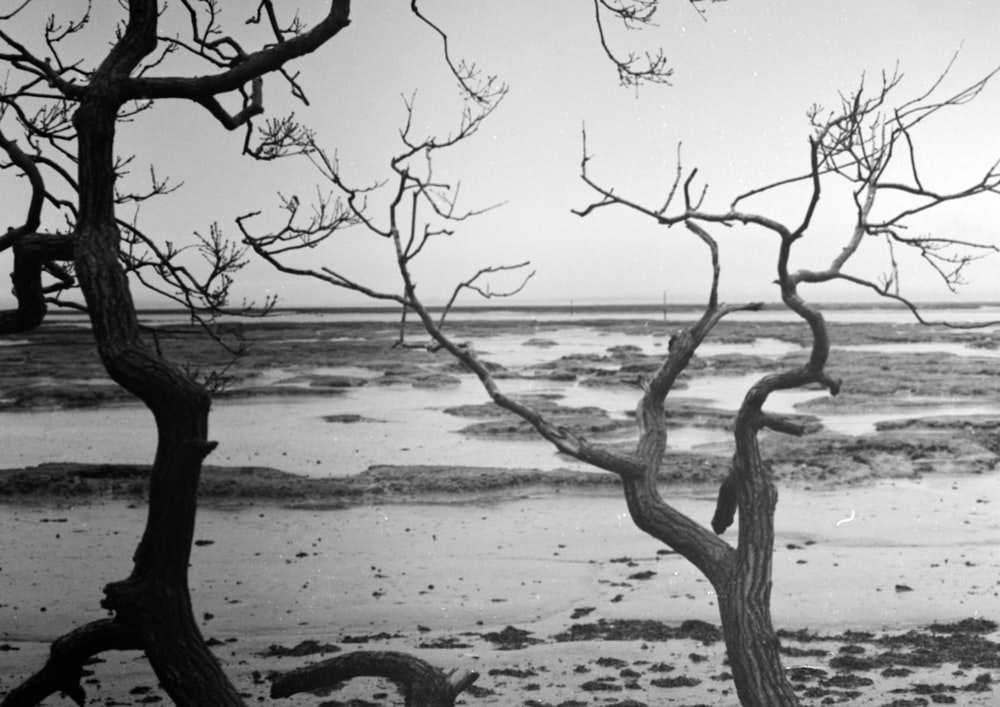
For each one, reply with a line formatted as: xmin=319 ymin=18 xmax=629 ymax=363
xmin=0 ymin=0 xmax=349 ymax=705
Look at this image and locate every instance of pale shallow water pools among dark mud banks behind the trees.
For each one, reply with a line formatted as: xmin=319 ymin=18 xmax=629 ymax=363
xmin=7 ymin=324 xmax=1000 ymax=476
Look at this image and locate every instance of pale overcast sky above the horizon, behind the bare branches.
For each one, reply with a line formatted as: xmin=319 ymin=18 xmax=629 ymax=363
xmin=0 ymin=0 xmax=1000 ymax=306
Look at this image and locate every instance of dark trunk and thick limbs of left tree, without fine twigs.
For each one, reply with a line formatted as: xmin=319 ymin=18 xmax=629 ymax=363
xmin=0 ymin=0 xmax=348 ymax=707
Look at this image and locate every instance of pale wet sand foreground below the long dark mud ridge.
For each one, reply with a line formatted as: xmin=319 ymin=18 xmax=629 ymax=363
xmin=0 ymin=476 xmax=1000 ymax=705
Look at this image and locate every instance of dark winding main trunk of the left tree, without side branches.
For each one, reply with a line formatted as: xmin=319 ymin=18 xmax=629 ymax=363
xmin=74 ymin=37 xmax=243 ymax=706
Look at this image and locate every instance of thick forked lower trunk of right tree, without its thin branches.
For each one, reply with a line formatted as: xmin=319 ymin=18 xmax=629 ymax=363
xmin=623 ymin=314 xmax=799 ymax=707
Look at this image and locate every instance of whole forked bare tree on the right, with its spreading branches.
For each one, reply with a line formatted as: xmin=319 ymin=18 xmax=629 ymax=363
xmin=246 ymin=60 xmax=1000 ymax=707
